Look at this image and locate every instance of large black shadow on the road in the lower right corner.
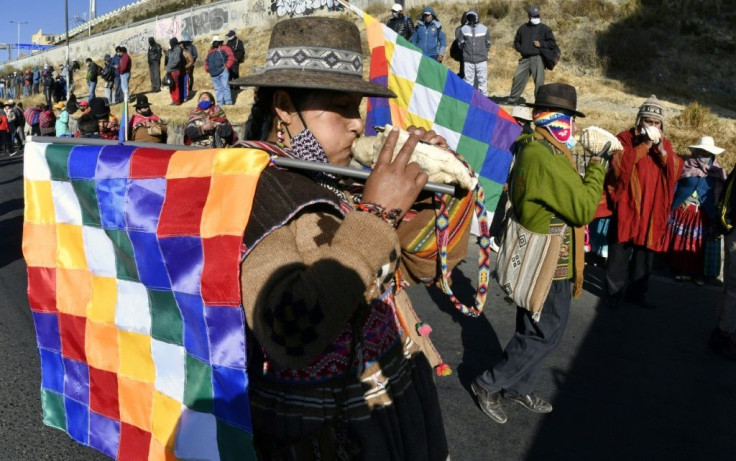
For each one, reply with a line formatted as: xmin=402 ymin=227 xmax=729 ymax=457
xmin=525 ymin=266 xmax=736 ymax=460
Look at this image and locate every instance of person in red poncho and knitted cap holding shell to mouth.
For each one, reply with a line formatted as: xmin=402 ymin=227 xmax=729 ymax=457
xmin=605 ymin=95 xmax=683 ymax=309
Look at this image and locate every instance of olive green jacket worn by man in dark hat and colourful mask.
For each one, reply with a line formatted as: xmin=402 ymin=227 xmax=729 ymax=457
xmin=511 ymin=129 xmax=606 ymax=278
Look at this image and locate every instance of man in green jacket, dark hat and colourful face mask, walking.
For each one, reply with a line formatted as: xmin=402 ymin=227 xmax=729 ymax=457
xmin=471 ymin=83 xmax=606 ymax=424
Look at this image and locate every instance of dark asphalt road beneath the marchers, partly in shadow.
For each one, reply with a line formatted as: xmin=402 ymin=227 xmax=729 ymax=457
xmin=0 ymin=150 xmax=736 ymax=461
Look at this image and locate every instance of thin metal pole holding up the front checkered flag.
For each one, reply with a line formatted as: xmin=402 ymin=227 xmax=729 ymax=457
xmin=28 ymin=136 xmax=458 ymax=196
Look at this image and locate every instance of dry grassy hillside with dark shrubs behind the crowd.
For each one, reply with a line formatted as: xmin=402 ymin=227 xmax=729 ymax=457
xmin=10 ymin=0 xmax=736 ymax=167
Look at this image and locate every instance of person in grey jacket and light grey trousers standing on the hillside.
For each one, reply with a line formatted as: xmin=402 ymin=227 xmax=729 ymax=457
xmin=455 ymin=10 xmax=491 ymax=96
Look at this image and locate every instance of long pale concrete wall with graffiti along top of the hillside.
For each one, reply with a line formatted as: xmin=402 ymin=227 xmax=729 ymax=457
xmin=6 ymin=0 xmax=478 ymax=69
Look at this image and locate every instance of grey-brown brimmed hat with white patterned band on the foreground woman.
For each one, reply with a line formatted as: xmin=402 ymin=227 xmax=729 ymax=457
xmin=230 ymin=16 xmax=396 ymax=98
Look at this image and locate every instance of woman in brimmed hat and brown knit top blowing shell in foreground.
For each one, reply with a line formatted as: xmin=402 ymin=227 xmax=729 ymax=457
xmin=232 ymin=17 xmax=448 ymax=461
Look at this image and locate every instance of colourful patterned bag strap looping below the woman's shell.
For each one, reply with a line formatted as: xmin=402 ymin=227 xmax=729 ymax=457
xmin=434 ymin=182 xmax=491 ymax=317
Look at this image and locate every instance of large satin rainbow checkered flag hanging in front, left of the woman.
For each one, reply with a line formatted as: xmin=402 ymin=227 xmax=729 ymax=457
xmin=23 ymin=142 xmax=269 ymax=460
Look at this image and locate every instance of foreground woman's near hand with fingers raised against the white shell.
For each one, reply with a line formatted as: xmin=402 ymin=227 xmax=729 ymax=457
xmin=363 ymin=128 xmax=432 ymax=219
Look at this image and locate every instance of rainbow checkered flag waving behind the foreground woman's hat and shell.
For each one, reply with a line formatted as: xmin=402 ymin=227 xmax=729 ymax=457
xmin=356 ymin=5 xmax=521 ymax=211
